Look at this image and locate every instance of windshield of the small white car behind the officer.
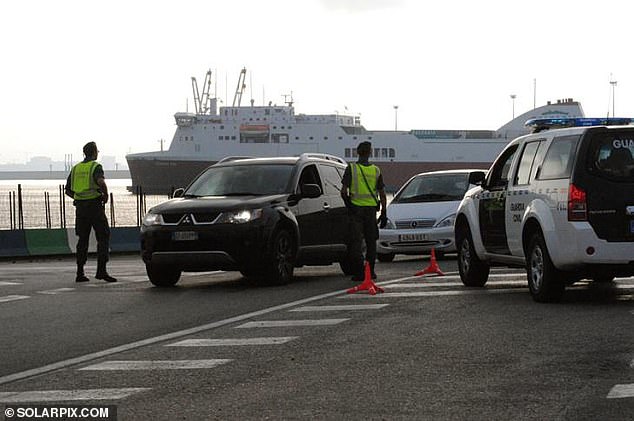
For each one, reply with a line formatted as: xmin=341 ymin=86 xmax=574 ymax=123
xmin=392 ymin=173 xmax=469 ymax=203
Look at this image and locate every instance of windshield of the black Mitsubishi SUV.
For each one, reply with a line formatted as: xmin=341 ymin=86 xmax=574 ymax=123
xmin=184 ymin=164 xmax=294 ymax=197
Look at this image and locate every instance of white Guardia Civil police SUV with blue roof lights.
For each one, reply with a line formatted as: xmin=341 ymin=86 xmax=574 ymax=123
xmin=455 ymin=118 xmax=634 ymax=302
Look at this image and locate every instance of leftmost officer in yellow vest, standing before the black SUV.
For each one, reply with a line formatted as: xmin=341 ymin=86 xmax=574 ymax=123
xmin=66 ymin=142 xmax=117 ymax=282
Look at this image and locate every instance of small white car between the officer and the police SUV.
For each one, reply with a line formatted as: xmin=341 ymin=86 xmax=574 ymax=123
xmin=377 ymin=169 xmax=486 ymax=262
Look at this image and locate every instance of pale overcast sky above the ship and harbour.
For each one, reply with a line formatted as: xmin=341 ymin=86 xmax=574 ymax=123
xmin=0 ymin=0 xmax=634 ymax=164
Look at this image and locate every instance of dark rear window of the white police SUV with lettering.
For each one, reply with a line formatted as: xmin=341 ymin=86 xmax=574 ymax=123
xmin=587 ymin=130 xmax=634 ymax=182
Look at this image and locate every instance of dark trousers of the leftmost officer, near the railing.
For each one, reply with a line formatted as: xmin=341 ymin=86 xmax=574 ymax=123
xmin=75 ymin=198 xmax=110 ymax=272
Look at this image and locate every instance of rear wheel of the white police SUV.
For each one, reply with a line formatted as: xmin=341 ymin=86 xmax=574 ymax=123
xmin=526 ymin=233 xmax=566 ymax=303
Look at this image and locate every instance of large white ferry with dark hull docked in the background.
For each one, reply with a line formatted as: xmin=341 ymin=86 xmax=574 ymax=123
xmin=126 ymin=69 xmax=585 ymax=195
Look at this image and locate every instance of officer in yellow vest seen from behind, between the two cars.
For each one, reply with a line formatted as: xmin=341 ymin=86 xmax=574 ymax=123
xmin=341 ymin=142 xmax=387 ymax=281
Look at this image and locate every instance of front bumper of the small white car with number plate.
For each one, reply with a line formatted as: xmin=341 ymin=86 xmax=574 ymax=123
xmin=377 ymin=227 xmax=456 ymax=254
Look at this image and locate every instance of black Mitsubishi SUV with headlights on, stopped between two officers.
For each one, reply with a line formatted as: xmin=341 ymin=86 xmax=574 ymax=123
xmin=141 ymin=154 xmax=353 ymax=286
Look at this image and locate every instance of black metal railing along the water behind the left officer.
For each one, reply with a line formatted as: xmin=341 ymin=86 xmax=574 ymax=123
xmin=0 ymin=184 xmax=169 ymax=230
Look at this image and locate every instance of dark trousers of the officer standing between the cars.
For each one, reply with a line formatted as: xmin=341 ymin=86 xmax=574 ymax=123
xmin=348 ymin=205 xmax=379 ymax=280
